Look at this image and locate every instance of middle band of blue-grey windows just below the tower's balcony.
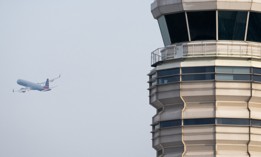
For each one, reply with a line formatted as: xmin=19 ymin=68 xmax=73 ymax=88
xmin=149 ymin=66 xmax=261 ymax=86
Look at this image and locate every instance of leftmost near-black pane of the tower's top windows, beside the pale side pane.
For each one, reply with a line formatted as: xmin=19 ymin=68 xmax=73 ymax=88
xmin=165 ymin=12 xmax=188 ymax=43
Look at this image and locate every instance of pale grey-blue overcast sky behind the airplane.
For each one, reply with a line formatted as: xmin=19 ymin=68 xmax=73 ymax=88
xmin=0 ymin=0 xmax=163 ymax=157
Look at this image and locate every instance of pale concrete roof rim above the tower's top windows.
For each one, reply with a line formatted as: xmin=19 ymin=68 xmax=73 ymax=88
xmin=151 ymin=0 xmax=261 ymax=18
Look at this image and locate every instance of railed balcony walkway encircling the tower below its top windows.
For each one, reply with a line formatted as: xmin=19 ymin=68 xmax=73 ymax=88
xmin=151 ymin=42 xmax=261 ymax=66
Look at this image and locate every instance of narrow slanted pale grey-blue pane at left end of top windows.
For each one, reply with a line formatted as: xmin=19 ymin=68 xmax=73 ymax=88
xmin=158 ymin=16 xmax=171 ymax=46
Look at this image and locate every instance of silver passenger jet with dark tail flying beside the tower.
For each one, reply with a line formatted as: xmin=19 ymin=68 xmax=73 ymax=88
xmin=13 ymin=75 xmax=61 ymax=93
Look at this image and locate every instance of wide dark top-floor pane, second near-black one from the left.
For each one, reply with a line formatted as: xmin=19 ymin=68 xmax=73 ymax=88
xmin=187 ymin=11 xmax=216 ymax=41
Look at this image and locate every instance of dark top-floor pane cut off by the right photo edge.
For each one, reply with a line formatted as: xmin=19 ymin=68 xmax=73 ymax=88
xmin=247 ymin=12 xmax=261 ymax=42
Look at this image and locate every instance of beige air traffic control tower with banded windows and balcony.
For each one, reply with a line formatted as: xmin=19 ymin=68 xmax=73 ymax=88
xmin=149 ymin=0 xmax=261 ymax=157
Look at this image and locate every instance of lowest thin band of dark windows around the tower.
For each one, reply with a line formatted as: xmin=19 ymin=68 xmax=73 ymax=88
xmin=152 ymin=118 xmax=261 ymax=130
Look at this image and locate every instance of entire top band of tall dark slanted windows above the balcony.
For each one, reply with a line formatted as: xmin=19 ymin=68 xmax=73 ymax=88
xmin=158 ymin=10 xmax=261 ymax=46
